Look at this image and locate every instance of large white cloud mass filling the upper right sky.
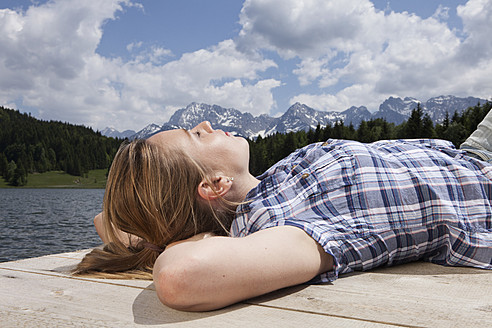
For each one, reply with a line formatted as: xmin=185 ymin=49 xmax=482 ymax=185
xmin=238 ymin=0 xmax=492 ymax=110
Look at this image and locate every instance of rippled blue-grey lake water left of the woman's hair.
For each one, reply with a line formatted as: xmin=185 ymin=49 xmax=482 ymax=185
xmin=0 ymin=189 xmax=104 ymax=262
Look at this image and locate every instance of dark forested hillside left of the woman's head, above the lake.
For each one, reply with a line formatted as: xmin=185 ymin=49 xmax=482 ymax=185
xmin=0 ymin=106 xmax=122 ymax=186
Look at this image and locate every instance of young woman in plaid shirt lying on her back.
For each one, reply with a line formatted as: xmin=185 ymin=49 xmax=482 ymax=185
xmin=76 ymin=114 xmax=492 ymax=311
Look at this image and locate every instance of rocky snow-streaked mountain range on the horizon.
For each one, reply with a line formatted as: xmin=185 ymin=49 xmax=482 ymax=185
xmin=101 ymin=96 xmax=487 ymax=139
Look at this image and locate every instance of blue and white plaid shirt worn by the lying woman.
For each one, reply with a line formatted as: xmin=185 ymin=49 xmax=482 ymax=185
xmin=231 ymin=140 xmax=492 ymax=282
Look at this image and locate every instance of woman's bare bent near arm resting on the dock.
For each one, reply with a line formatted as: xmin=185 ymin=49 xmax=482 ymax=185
xmin=154 ymin=226 xmax=333 ymax=311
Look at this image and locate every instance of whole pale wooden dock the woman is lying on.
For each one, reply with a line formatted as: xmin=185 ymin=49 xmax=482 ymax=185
xmin=0 ymin=251 xmax=492 ymax=328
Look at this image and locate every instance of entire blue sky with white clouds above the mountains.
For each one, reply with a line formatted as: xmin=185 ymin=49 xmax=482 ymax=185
xmin=0 ymin=0 xmax=492 ymax=131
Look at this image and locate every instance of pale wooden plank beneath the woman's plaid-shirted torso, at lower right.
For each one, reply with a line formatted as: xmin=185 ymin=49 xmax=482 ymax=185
xmin=249 ymin=262 xmax=492 ymax=327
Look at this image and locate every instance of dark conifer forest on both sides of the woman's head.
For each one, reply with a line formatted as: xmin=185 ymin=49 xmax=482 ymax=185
xmin=0 ymin=102 xmax=492 ymax=186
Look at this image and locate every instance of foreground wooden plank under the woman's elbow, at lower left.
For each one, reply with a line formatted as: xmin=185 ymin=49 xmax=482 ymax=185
xmin=0 ymin=269 xmax=394 ymax=327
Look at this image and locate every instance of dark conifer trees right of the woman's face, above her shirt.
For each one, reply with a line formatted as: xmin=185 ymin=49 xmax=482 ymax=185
xmin=248 ymin=102 xmax=492 ymax=175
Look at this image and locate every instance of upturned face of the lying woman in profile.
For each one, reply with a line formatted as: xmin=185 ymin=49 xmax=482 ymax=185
xmin=148 ymin=121 xmax=249 ymax=177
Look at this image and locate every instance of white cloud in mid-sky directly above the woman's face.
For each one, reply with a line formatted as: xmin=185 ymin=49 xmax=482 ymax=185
xmin=113 ymin=40 xmax=280 ymax=118
